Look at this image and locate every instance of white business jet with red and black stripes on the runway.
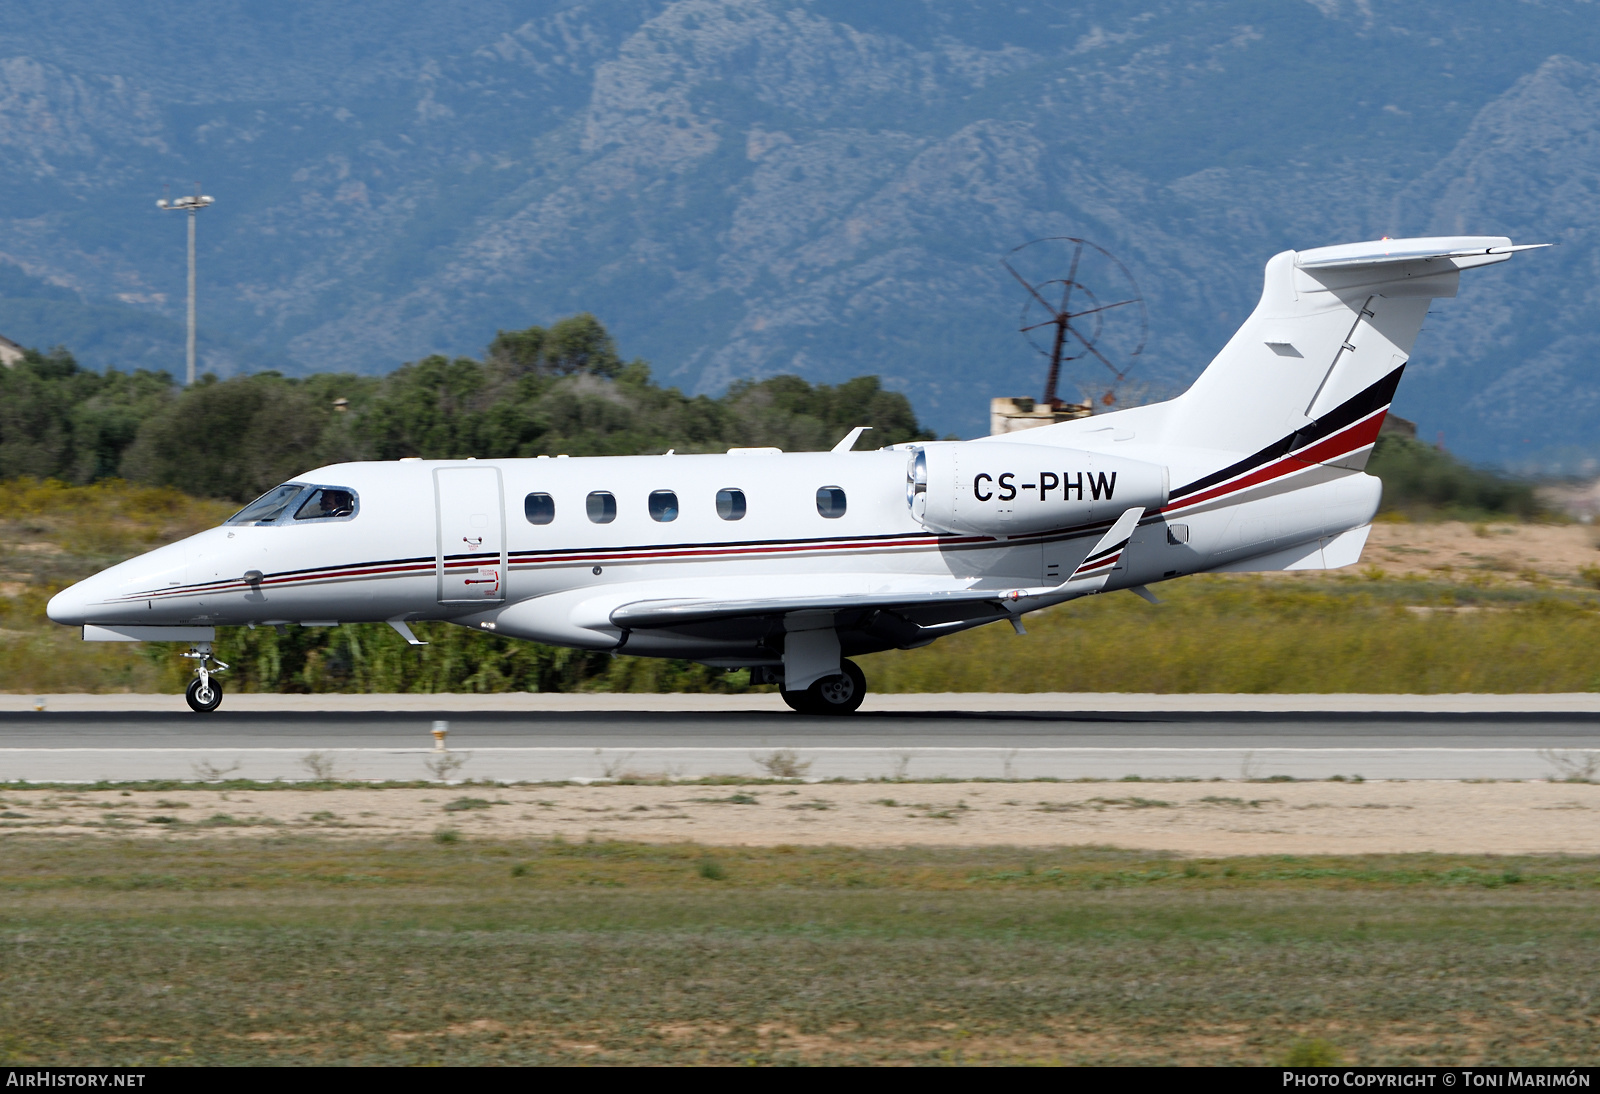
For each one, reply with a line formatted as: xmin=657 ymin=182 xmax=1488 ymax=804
xmin=48 ymin=237 xmax=1528 ymax=713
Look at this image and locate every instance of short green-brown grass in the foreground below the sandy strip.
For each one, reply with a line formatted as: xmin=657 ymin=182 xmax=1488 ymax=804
xmin=0 ymin=836 xmax=1600 ymax=1065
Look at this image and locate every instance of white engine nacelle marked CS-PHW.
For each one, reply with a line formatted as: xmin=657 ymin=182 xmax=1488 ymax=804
xmin=906 ymin=441 xmax=1168 ymax=536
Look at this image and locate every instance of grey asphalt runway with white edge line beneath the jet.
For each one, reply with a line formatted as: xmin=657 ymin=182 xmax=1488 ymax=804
xmin=0 ymin=701 xmax=1600 ymax=782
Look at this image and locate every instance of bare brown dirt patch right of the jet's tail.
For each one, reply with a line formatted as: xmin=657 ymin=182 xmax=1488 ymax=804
xmin=1360 ymin=521 xmax=1600 ymax=584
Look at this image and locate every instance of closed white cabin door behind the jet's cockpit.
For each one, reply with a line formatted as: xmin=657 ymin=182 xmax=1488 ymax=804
xmin=434 ymin=467 xmax=506 ymax=605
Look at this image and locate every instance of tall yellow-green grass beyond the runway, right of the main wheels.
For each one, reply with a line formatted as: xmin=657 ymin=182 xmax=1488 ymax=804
xmin=859 ymin=576 xmax=1600 ymax=694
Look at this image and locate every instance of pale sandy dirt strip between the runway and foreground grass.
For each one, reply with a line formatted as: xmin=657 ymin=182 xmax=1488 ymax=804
xmin=9 ymin=782 xmax=1600 ymax=857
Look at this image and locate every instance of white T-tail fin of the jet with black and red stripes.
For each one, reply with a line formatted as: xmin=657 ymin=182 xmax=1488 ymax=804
xmin=986 ymin=235 xmax=1547 ymax=510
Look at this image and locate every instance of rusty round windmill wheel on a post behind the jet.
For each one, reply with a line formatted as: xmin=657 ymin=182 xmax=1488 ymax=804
xmin=1000 ymin=235 xmax=1150 ymax=414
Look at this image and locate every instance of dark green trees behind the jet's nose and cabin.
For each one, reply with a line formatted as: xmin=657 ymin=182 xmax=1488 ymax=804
xmin=0 ymin=312 xmax=931 ymax=502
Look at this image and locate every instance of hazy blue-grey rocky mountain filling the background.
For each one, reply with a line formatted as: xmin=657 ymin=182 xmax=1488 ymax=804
xmin=0 ymin=0 xmax=1600 ymax=469
